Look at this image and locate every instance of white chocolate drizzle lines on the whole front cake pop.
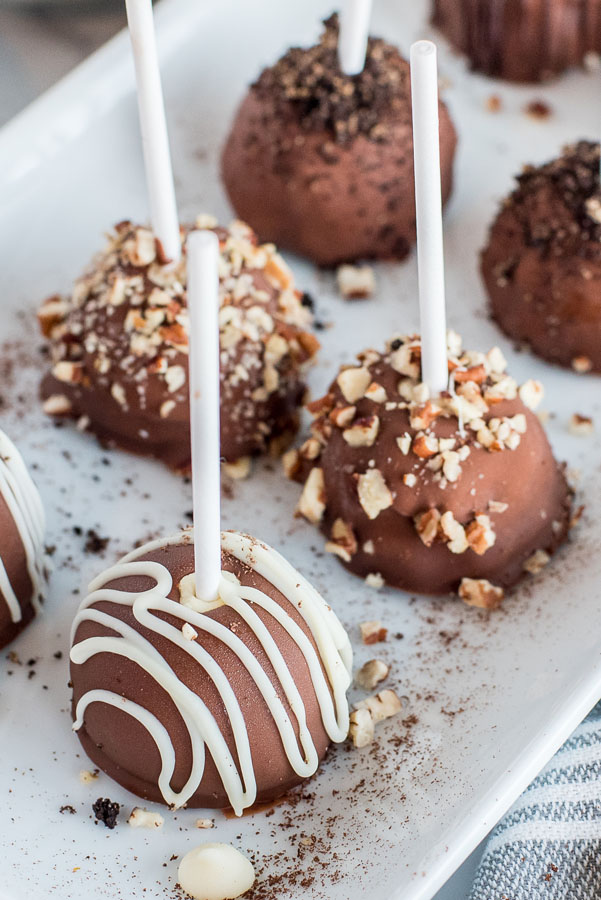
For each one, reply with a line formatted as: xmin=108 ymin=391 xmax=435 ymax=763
xmin=71 ymin=531 xmax=352 ymax=815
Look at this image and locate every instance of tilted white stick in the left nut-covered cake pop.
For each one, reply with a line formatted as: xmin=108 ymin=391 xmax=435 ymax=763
xmin=125 ymin=0 xmax=181 ymax=262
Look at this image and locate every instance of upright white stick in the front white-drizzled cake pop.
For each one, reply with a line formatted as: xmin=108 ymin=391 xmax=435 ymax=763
xmin=187 ymin=231 xmax=221 ymax=603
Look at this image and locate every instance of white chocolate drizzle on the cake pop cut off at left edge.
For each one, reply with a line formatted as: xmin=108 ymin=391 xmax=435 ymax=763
xmin=0 ymin=431 xmax=46 ymax=623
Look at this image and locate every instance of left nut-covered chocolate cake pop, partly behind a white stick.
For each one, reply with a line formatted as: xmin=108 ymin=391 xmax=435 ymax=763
xmin=40 ymin=216 xmax=319 ymax=470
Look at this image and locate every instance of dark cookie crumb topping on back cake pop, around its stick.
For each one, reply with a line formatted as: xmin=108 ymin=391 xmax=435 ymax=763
xmin=252 ymin=14 xmax=410 ymax=144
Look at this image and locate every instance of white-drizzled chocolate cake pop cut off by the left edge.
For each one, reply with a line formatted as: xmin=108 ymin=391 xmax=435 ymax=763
xmin=0 ymin=431 xmax=46 ymax=648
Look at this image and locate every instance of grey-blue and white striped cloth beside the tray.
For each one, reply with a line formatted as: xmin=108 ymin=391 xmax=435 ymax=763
xmin=470 ymin=703 xmax=601 ymax=900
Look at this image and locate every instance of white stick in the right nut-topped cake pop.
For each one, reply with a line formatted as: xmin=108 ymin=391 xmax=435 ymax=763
xmin=410 ymin=41 xmax=449 ymax=396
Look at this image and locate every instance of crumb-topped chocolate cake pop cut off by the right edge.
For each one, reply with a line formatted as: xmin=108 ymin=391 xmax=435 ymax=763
xmin=481 ymin=141 xmax=601 ymax=372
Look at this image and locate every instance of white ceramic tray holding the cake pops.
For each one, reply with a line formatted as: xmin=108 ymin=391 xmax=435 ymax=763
xmin=0 ymin=0 xmax=601 ymax=900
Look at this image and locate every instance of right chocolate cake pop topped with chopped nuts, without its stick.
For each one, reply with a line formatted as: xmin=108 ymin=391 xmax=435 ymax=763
xmin=285 ymin=333 xmax=570 ymax=606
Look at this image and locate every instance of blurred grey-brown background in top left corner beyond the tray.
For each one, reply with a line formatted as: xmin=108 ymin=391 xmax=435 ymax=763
xmin=0 ymin=0 xmax=125 ymax=126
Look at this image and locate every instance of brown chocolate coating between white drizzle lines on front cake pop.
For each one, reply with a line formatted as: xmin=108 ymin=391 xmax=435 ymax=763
xmin=71 ymin=542 xmax=336 ymax=808
